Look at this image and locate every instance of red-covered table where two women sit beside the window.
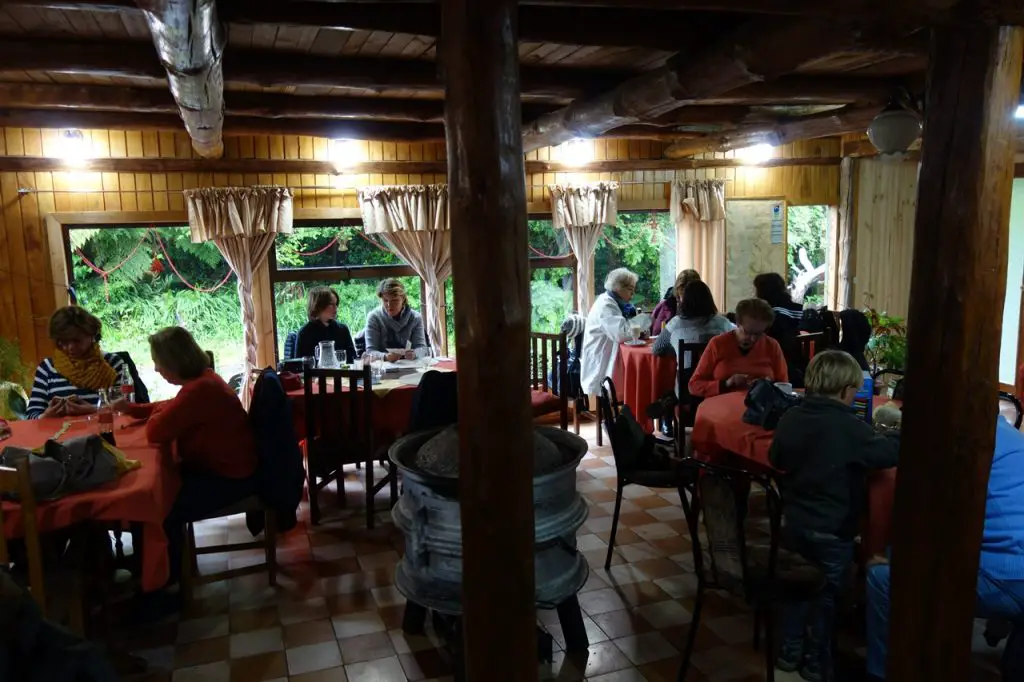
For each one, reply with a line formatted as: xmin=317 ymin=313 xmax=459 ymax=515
xmin=287 ymin=358 xmax=456 ymax=445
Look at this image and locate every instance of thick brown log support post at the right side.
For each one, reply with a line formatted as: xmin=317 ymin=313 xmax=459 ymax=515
xmin=888 ymin=25 xmax=1024 ymax=682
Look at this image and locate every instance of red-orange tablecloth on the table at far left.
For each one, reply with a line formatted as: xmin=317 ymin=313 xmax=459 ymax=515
xmin=0 ymin=418 xmax=181 ymax=592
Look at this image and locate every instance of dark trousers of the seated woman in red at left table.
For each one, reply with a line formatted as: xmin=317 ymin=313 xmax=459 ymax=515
xmin=164 ymin=471 xmax=257 ymax=585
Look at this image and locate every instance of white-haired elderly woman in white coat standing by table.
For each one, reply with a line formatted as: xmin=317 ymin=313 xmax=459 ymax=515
xmin=580 ymin=267 xmax=637 ymax=395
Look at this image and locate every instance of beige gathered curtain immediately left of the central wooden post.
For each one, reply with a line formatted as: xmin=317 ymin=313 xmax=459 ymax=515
xmin=359 ymin=184 xmax=452 ymax=352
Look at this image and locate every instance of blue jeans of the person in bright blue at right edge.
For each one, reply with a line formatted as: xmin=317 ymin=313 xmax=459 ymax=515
xmin=867 ymin=564 xmax=1024 ymax=681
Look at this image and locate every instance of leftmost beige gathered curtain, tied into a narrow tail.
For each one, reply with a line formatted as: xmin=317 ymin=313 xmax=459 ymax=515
xmin=184 ymin=186 xmax=292 ymax=404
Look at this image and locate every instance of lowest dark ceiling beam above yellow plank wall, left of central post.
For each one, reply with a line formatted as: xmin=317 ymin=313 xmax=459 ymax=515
xmin=0 ymin=109 xmax=444 ymax=142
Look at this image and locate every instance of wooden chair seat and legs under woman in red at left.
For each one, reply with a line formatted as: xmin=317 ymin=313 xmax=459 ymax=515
xmin=181 ymin=495 xmax=278 ymax=604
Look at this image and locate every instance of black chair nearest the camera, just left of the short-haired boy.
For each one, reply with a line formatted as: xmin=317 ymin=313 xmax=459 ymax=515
xmin=677 ymin=459 xmax=828 ymax=682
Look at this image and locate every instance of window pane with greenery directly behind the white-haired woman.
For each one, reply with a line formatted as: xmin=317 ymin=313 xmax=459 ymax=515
xmin=594 ymin=211 xmax=675 ymax=312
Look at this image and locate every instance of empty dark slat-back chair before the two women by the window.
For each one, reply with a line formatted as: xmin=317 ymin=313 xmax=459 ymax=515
xmin=303 ymin=365 xmax=398 ymax=528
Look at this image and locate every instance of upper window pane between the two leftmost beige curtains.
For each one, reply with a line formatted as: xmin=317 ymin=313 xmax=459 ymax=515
xmin=274 ymin=226 xmax=404 ymax=269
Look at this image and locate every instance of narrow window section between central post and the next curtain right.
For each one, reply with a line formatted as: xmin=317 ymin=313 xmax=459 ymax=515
xmin=527 ymin=219 xmax=575 ymax=334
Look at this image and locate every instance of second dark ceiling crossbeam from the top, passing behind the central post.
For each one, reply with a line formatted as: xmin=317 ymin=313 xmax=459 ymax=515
xmin=0 ymin=39 xmax=622 ymax=101
